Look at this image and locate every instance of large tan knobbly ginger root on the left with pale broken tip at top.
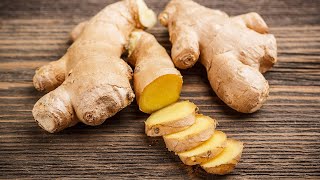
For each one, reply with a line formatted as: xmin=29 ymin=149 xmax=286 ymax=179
xmin=32 ymin=0 xmax=155 ymax=133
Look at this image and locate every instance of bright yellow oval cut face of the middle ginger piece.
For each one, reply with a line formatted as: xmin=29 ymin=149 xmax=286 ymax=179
xmin=139 ymin=74 xmax=183 ymax=113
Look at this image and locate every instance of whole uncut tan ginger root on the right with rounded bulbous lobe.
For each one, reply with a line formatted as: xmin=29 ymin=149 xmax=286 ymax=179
xmin=159 ymin=0 xmax=277 ymax=113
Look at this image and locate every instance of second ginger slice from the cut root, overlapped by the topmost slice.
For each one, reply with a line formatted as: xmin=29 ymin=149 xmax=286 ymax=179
xmin=163 ymin=114 xmax=217 ymax=153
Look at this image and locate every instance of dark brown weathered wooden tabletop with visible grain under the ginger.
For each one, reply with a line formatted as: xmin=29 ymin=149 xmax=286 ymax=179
xmin=0 ymin=0 xmax=320 ymax=179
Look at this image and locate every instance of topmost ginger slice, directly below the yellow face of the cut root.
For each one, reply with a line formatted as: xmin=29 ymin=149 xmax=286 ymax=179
xmin=145 ymin=101 xmax=197 ymax=136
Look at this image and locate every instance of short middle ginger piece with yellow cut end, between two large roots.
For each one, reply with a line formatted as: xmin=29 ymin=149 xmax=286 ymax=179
xmin=129 ymin=31 xmax=183 ymax=113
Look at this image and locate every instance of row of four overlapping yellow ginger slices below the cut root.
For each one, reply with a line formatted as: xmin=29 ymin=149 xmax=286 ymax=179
xmin=145 ymin=101 xmax=243 ymax=175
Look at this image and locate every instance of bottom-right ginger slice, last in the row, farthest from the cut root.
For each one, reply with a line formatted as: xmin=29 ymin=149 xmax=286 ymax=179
xmin=201 ymin=139 xmax=243 ymax=175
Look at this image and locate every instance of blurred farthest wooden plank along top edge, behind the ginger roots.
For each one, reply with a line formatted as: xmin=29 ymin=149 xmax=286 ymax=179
xmin=0 ymin=0 xmax=320 ymax=25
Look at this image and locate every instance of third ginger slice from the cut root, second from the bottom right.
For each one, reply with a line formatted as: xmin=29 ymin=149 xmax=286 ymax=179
xmin=178 ymin=131 xmax=227 ymax=166
